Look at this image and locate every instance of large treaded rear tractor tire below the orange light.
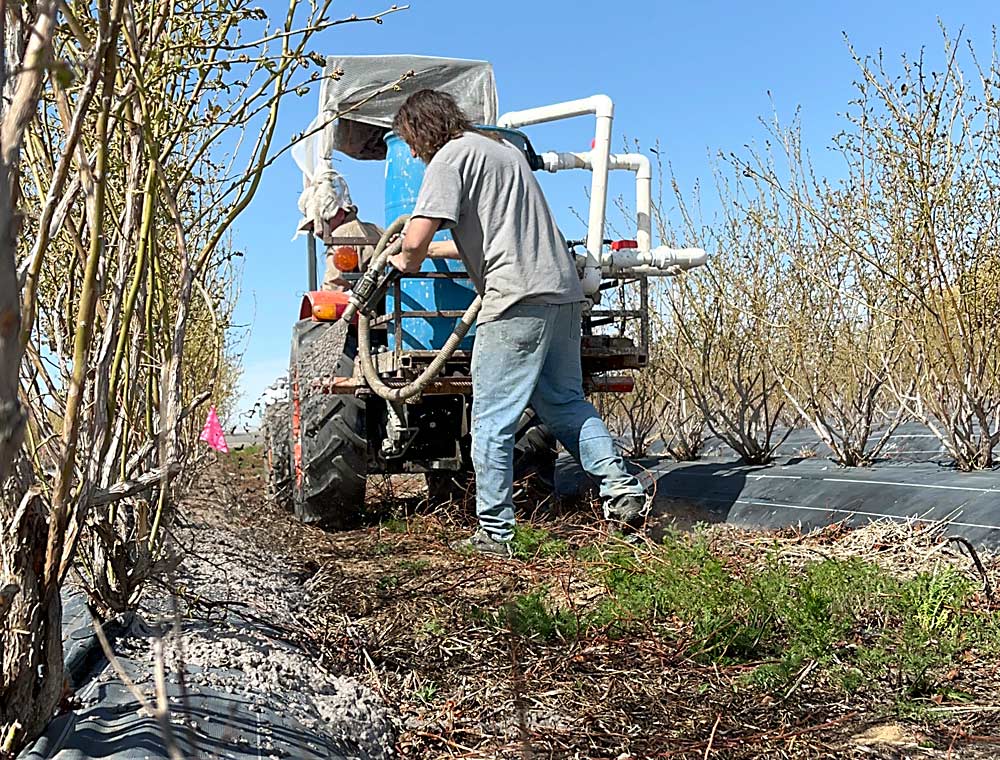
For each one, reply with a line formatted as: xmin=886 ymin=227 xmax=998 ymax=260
xmin=288 ymin=319 xmax=368 ymax=529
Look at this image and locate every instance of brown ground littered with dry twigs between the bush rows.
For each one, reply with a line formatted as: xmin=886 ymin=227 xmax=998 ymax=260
xmin=184 ymin=451 xmax=1000 ymax=760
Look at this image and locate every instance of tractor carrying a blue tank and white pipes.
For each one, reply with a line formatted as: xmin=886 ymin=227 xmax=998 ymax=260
xmin=262 ymin=56 xmax=706 ymax=528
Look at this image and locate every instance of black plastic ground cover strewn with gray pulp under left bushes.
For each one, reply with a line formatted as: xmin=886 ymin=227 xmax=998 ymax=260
xmin=19 ymin=502 xmax=393 ymax=760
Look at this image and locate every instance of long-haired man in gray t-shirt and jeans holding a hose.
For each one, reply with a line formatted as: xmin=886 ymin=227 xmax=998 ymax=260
xmin=390 ymin=90 xmax=645 ymax=556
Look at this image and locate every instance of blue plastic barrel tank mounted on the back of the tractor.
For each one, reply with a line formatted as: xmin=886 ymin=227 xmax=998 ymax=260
xmin=385 ymin=127 xmax=540 ymax=351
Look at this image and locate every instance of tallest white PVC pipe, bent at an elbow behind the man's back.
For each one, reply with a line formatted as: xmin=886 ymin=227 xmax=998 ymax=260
xmin=497 ymin=95 xmax=615 ymax=295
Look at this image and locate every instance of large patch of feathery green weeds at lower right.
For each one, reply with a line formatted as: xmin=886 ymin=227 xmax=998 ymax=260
xmin=578 ymin=534 xmax=1000 ymax=699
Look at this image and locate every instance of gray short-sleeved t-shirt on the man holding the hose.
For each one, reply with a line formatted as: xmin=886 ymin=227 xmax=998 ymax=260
xmin=413 ymin=132 xmax=583 ymax=322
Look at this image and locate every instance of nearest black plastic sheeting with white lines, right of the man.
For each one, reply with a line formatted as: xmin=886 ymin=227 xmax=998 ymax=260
xmin=556 ymin=458 xmax=1000 ymax=549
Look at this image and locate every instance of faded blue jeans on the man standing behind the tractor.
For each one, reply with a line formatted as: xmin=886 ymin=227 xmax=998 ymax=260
xmin=472 ymin=303 xmax=643 ymax=541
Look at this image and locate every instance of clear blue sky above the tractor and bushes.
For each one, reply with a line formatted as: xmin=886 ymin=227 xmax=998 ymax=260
xmin=229 ymin=0 xmax=1000 ymax=422
